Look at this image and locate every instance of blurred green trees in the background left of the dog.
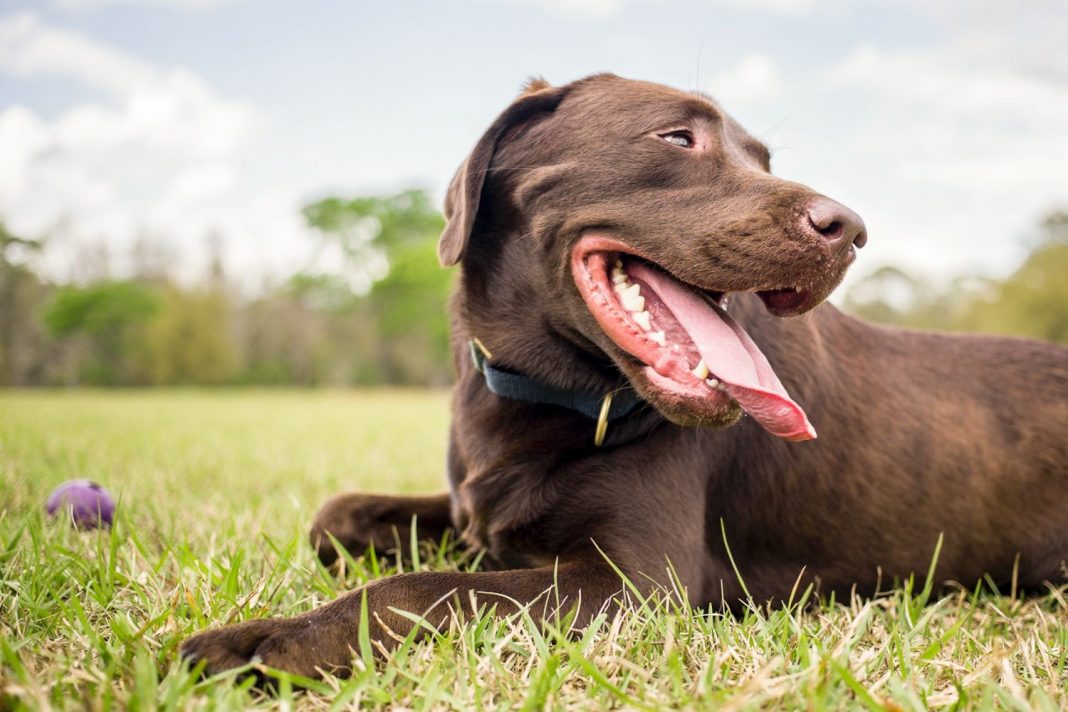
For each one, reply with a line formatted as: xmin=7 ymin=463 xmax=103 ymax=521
xmin=0 ymin=191 xmax=452 ymax=385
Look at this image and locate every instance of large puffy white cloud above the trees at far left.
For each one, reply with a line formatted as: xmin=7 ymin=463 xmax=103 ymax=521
xmin=0 ymin=14 xmax=310 ymax=283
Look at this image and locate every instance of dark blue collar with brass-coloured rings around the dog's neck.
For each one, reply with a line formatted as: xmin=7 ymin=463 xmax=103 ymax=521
xmin=468 ymin=338 xmax=644 ymax=446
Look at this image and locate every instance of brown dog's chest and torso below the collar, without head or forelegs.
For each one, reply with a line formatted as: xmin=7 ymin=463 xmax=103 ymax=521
xmin=451 ymin=299 xmax=1068 ymax=606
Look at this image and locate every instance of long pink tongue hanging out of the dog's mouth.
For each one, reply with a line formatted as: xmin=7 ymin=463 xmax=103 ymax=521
xmin=627 ymin=263 xmax=816 ymax=441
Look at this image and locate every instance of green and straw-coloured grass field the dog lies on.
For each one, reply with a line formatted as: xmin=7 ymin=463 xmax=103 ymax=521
xmin=0 ymin=392 xmax=1068 ymax=710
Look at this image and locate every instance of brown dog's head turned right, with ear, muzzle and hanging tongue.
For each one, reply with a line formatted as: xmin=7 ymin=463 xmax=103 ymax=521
xmin=439 ymin=75 xmax=866 ymax=440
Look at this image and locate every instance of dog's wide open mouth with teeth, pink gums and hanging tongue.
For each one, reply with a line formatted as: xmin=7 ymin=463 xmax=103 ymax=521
xmin=571 ymin=236 xmax=816 ymax=441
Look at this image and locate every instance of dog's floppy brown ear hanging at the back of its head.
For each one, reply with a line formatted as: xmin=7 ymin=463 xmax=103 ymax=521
xmin=438 ymin=78 xmax=565 ymax=267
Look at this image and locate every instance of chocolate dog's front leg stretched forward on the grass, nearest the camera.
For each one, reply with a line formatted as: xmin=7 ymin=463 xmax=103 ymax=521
xmin=182 ymin=557 xmax=623 ymax=678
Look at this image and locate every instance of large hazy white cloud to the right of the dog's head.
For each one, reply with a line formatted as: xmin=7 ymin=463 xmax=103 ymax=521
xmin=820 ymin=47 xmax=1068 ymax=274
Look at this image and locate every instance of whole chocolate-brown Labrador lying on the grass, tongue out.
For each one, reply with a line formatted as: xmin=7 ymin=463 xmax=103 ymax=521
xmin=183 ymin=75 xmax=1068 ymax=676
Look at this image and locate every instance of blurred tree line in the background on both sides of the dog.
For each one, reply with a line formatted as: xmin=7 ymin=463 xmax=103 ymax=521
xmin=0 ymin=196 xmax=1068 ymax=386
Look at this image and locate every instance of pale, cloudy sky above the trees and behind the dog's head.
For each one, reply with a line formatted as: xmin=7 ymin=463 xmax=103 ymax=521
xmin=0 ymin=0 xmax=1068 ymax=292
